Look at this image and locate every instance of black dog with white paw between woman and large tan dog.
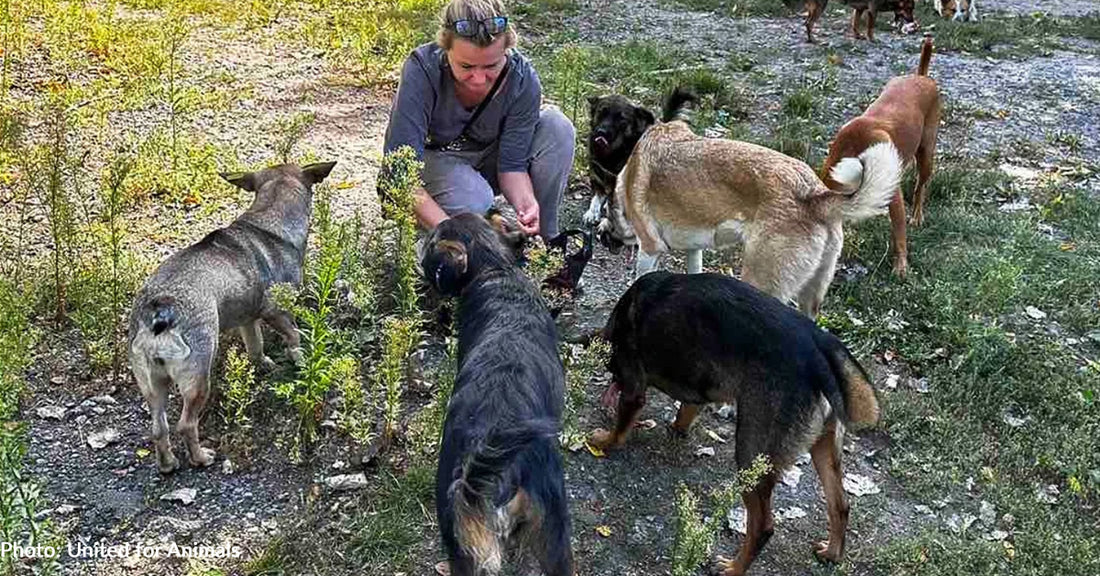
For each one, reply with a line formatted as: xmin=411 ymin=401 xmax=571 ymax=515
xmin=582 ymin=95 xmax=657 ymax=226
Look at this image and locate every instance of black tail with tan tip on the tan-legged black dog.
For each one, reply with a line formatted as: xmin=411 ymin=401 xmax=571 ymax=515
xmin=814 ymin=330 xmax=879 ymax=427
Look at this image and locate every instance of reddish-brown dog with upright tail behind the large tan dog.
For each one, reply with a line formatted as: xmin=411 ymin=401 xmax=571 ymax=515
xmin=821 ymin=34 xmax=941 ymax=277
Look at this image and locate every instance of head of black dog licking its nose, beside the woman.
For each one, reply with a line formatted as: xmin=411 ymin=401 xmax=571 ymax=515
xmin=589 ymin=95 xmax=657 ymax=180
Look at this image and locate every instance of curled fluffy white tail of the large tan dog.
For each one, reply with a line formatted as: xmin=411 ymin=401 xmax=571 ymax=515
xmin=829 ymin=142 xmax=902 ymax=222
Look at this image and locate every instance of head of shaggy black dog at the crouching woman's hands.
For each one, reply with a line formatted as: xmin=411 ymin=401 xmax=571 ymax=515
xmin=420 ymin=209 xmax=524 ymax=296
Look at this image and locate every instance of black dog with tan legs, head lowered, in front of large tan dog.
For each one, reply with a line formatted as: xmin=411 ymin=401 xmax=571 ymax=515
xmin=590 ymin=272 xmax=879 ymax=576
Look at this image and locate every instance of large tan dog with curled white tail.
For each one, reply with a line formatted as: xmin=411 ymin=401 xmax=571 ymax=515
xmin=598 ymin=90 xmax=902 ymax=315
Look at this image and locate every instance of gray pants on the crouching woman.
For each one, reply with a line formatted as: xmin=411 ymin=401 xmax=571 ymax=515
xmin=420 ymin=108 xmax=575 ymax=240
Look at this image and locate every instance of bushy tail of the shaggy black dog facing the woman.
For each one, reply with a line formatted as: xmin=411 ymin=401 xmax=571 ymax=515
xmin=450 ymin=419 xmax=560 ymax=574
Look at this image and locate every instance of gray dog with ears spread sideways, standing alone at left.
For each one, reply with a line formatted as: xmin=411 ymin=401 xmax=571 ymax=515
xmin=130 ymin=162 xmax=336 ymax=474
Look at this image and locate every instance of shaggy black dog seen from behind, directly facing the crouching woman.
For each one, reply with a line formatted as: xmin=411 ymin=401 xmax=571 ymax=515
xmin=421 ymin=214 xmax=573 ymax=576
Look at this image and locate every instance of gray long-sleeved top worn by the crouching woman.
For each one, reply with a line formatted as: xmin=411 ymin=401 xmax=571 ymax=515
xmin=383 ymin=43 xmax=542 ymax=173
